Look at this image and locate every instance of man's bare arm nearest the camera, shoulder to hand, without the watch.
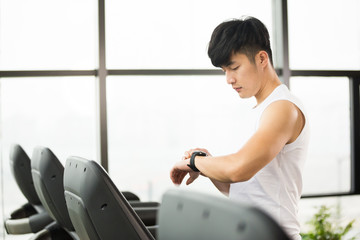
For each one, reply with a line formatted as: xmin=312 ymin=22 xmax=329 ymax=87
xmin=171 ymin=101 xmax=304 ymax=184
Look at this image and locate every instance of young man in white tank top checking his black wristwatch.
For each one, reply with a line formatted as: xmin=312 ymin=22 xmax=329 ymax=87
xmin=170 ymin=17 xmax=309 ymax=239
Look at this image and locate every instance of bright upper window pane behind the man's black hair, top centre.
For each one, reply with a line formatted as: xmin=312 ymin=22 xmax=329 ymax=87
xmin=105 ymin=0 xmax=272 ymax=69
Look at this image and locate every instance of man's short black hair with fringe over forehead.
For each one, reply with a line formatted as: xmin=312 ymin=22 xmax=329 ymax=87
xmin=208 ymin=17 xmax=273 ymax=67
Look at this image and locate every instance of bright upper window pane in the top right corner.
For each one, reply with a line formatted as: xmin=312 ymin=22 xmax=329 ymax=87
xmin=288 ymin=0 xmax=360 ymax=70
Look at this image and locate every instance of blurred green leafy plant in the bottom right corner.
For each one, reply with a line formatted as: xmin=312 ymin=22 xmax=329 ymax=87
xmin=301 ymin=205 xmax=356 ymax=240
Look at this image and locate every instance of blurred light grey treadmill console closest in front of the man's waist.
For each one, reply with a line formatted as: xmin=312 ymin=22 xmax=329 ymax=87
xmin=158 ymin=189 xmax=290 ymax=240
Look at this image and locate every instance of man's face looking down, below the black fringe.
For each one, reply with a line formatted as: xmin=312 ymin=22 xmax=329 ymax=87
xmin=221 ymin=53 xmax=261 ymax=98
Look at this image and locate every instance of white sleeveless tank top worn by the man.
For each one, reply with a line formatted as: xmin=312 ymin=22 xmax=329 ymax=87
xmin=229 ymin=85 xmax=310 ymax=240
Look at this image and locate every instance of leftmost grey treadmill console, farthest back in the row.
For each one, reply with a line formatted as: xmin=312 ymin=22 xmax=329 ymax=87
xmin=4 ymin=144 xmax=53 ymax=234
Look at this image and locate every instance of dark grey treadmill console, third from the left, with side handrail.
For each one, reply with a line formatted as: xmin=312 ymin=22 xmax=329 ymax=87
xmin=64 ymin=157 xmax=158 ymax=240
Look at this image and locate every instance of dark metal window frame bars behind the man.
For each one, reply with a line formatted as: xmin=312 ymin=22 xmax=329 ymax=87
xmin=0 ymin=0 xmax=360 ymax=198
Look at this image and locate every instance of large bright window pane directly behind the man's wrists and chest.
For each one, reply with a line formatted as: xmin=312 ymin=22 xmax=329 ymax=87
xmin=107 ymin=76 xmax=255 ymax=201
